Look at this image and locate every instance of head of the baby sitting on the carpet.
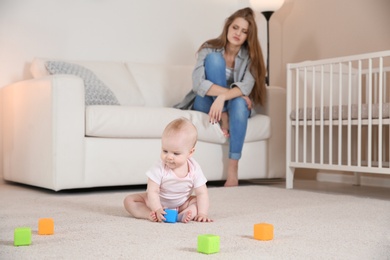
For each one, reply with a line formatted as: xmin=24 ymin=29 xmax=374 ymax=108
xmin=161 ymin=118 xmax=198 ymax=169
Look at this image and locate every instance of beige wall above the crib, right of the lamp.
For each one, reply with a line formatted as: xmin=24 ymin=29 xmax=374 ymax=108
xmin=270 ymin=0 xmax=390 ymax=86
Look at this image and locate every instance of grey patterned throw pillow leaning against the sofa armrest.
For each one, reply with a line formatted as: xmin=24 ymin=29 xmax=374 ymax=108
xmin=45 ymin=61 xmax=120 ymax=106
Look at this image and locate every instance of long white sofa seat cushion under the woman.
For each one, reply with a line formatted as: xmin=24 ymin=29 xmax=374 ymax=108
xmin=86 ymin=106 xmax=270 ymax=144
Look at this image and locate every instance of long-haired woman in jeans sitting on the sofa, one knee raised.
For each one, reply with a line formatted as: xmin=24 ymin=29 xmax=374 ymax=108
xmin=176 ymin=8 xmax=266 ymax=186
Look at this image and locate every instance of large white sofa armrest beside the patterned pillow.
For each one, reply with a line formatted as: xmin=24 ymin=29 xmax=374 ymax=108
xmin=2 ymin=75 xmax=85 ymax=190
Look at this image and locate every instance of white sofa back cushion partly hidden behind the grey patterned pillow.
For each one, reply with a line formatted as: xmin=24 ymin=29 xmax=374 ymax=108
xmin=30 ymin=58 xmax=145 ymax=106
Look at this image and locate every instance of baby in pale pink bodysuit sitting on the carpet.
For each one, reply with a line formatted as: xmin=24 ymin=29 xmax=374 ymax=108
xmin=124 ymin=118 xmax=212 ymax=223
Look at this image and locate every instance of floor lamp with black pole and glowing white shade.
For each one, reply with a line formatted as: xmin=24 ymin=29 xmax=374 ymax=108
xmin=250 ymin=0 xmax=284 ymax=86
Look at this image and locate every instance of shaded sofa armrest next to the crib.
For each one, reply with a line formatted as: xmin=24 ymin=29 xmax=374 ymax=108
xmin=256 ymin=86 xmax=286 ymax=178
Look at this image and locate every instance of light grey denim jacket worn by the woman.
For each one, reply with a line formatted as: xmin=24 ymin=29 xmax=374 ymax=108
xmin=174 ymin=46 xmax=255 ymax=109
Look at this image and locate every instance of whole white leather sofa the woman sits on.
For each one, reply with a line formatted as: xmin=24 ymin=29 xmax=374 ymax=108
xmin=2 ymin=58 xmax=286 ymax=191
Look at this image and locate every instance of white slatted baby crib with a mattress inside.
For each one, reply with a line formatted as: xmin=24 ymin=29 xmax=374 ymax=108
xmin=286 ymin=50 xmax=390 ymax=189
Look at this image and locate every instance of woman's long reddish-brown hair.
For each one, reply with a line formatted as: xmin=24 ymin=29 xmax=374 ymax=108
xmin=199 ymin=7 xmax=266 ymax=105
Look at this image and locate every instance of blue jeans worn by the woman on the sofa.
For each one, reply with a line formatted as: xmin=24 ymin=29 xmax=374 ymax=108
xmin=192 ymin=52 xmax=250 ymax=160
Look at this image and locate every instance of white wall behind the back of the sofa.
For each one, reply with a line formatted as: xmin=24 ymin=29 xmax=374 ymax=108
xmin=0 ymin=0 xmax=256 ymax=87
